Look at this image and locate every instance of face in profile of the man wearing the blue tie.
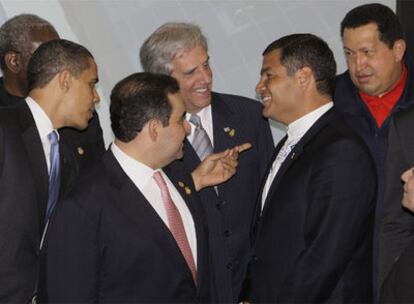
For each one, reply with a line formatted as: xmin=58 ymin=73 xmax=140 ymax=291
xmin=65 ymin=58 xmax=100 ymax=130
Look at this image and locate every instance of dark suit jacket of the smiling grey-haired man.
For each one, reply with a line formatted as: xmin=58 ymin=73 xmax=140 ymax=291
xmin=177 ymin=93 xmax=274 ymax=302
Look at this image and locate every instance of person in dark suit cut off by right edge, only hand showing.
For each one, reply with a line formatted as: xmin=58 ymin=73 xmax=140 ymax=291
xmin=380 ymin=107 xmax=414 ymax=303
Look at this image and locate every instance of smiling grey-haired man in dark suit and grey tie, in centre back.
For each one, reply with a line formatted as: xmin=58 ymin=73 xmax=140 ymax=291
xmin=140 ymin=23 xmax=274 ymax=302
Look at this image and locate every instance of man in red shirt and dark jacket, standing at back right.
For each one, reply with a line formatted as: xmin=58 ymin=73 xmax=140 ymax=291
xmin=334 ymin=3 xmax=414 ymax=295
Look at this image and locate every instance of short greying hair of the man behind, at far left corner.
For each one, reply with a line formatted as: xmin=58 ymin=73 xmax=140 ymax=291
xmin=0 ymin=14 xmax=58 ymax=71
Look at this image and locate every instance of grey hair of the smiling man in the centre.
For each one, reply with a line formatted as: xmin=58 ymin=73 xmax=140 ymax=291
xmin=139 ymin=22 xmax=208 ymax=75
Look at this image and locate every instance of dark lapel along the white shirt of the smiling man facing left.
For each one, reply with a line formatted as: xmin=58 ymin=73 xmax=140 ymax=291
xmin=262 ymin=109 xmax=334 ymax=214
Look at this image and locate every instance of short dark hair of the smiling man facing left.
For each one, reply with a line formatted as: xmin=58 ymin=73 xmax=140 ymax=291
xmin=263 ymin=34 xmax=336 ymax=97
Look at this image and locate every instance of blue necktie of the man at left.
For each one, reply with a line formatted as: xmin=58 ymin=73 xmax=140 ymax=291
xmin=45 ymin=131 xmax=60 ymax=222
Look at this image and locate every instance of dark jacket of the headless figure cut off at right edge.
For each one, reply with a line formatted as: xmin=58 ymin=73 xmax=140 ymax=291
xmin=381 ymin=107 xmax=414 ymax=296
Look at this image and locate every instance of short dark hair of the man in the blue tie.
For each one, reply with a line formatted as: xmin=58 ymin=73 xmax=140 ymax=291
xmin=27 ymin=39 xmax=93 ymax=91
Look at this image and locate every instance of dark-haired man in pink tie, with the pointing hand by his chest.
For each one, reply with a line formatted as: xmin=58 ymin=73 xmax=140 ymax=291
xmin=47 ymin=73 xmax=251 ymax=303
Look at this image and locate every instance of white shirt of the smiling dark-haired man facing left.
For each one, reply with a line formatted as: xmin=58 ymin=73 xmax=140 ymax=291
xmin=262 ymin=102 xmax=333 ymax=210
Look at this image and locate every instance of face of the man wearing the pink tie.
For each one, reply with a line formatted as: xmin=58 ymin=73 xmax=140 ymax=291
xmin=159 ymin=93 xmax=191 ymax=165
